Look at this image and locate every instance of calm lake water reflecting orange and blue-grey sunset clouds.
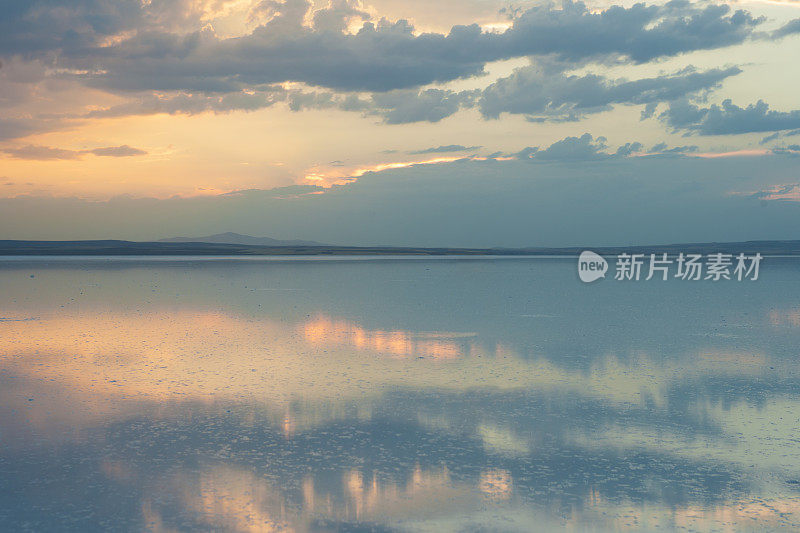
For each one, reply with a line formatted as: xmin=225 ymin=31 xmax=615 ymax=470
xmin=0 ymin=258 xmax=800 ymax=532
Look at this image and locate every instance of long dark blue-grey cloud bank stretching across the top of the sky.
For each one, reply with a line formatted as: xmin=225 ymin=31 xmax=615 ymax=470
xmin=0 ymin=0 xmax=760 ymax=92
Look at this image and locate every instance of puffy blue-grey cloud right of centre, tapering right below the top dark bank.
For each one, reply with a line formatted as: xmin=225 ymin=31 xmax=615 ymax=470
xmin=478 ymin=66 xmax=741 ymax=120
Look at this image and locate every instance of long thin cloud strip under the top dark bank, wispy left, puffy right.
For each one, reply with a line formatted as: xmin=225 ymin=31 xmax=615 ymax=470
xmin=85 ymin=62 xmax=741 ymax=128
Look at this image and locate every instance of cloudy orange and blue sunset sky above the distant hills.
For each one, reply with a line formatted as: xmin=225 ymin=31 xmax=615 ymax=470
xmin=0 ymin=0 xmax=800 ymax=247
